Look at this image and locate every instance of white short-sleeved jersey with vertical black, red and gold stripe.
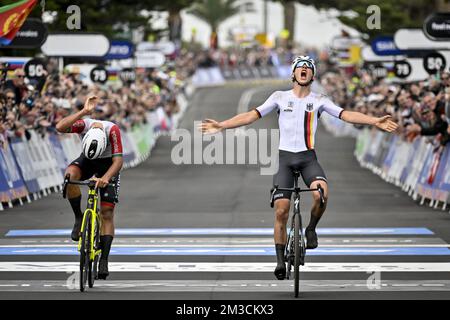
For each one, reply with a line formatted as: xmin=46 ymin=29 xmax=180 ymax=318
xmin=255 ymin=90 xmax=344 ymax=152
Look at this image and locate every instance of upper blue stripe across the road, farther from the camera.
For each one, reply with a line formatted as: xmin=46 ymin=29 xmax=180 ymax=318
xmin=6 ymin=228 xmax=434 ymax=237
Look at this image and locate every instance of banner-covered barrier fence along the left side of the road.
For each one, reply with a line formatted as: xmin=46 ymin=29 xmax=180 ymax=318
xmin=0 ymin=90 xmax=192 ymax=210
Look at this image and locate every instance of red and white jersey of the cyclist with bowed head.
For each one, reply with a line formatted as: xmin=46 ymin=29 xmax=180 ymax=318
xmin=70 ymin=119 xmax=123 ymax=158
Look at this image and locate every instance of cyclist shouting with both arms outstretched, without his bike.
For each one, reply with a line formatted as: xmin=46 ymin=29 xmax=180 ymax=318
xmin=199 ymin=56 xmax=398 ymax=280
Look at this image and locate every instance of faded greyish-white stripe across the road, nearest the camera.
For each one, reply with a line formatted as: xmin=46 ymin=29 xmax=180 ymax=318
xmin=0 ymin=280 xmax=450 ymax=292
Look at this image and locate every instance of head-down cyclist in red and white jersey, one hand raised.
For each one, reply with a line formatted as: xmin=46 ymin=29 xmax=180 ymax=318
xmin=56 ymin=96 xmax=123 ymax=279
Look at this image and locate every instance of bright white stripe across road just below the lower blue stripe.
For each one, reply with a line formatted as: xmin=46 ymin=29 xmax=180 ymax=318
xmin=0 ymin=261 xmax=450 ymax=273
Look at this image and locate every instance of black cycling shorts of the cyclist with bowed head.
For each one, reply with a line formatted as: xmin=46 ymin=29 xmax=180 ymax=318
xmin=70 ymin=154 xmax=120 ymax=208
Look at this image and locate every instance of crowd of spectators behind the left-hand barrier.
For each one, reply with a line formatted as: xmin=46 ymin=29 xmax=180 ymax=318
xmin=0 ymin=57 xmax=188 ymax=148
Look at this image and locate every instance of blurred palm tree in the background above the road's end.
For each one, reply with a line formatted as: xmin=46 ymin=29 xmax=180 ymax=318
xmin=187 ymin=0 xmax=239 ymax=49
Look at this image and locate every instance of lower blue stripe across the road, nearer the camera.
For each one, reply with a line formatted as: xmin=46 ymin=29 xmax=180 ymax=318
xmin=0 ymin=245 xmax=450 ymax=256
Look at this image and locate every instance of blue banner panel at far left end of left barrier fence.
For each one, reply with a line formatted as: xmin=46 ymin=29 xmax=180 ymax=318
xmin=0 ymin=143 xmax=28 ymax=200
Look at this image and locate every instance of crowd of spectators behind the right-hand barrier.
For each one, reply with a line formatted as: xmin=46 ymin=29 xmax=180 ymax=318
xmin=321 ymin=70 xmax=450 ymax=145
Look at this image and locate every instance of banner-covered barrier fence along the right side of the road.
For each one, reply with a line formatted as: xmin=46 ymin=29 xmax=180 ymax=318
xmin=321 ymin=114 xmax=450 ymax=210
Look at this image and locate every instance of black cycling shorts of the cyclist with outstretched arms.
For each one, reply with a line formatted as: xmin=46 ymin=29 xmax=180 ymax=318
xmin=273 ymin=150 xmax=327 ymax=200
